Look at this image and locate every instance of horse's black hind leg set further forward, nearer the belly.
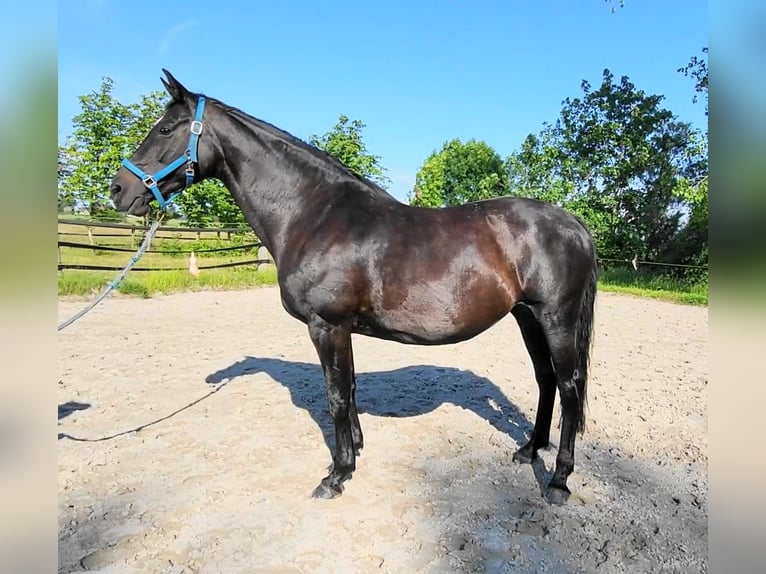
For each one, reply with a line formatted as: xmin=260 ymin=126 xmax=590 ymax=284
xmin=511 ymin=304 xmax=556 ymax=463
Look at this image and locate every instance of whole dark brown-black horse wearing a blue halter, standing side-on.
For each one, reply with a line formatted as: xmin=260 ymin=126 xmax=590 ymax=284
xmin=111 ymin=70 xmax=597 ymax=503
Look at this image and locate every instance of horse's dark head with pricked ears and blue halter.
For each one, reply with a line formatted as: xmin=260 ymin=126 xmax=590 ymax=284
xmin=110 ymin=69 xmax=213 ymax=215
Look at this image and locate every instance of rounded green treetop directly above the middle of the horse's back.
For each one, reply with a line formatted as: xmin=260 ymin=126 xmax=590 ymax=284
xmin=410 ymin=139 xmax=507 ymax=207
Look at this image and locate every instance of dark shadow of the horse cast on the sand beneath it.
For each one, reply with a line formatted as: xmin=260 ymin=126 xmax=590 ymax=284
xmin=205 ymin=357 xmax=549 ymax=496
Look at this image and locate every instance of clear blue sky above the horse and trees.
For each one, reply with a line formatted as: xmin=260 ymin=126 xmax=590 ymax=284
xmin=58 ymin=0 xmax=708 ymax=200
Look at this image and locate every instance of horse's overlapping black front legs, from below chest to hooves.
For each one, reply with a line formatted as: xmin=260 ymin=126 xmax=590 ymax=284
xmin=309 ymin=318 xmax=356 ymax=498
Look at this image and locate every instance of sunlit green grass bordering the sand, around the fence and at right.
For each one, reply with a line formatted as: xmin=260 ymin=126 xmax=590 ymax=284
xmin=58 ymin=224 xmax=708 ymax=305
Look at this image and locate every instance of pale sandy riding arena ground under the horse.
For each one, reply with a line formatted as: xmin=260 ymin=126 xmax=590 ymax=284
xmin=58 ymin=288 xmax=708 ymax=574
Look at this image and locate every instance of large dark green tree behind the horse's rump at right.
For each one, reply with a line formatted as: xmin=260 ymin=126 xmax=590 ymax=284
xmin=508 ymin=70 xmax=707 ymax=259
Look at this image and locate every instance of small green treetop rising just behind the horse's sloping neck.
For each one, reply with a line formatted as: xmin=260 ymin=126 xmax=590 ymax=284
xmin=309 ymin=114 xmax=391 ymax=188
